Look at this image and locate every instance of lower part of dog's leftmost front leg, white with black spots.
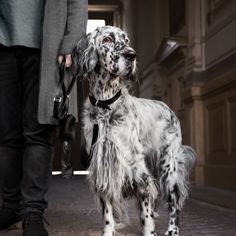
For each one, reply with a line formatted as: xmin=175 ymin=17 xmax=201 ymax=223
xmin=101 ymin=199 xmax=115 ymax=236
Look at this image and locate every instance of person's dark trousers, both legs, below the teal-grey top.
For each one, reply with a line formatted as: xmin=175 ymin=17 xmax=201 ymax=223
xmin=0 ymin=45 xmax=53 ymax=213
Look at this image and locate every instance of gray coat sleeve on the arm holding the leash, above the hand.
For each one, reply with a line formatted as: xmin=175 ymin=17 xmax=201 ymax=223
xmin=58 ymin=0 xmax=88 ymax=55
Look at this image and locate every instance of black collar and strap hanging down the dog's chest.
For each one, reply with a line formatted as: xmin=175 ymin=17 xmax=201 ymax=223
xmin=88 ymin=90 xmax=121 ymax=162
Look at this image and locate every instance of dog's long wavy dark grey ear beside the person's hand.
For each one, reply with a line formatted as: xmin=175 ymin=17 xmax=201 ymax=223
xmin=72 ymin=33 xmax=98 ymax=79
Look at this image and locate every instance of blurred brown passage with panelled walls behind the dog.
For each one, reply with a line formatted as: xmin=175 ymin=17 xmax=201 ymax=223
xmin=54 ymin=0 xmax=236 ymax=194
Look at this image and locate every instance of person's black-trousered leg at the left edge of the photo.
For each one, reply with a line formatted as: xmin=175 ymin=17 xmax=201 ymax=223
xmin=0 ymin=45 xmax=23 ymax=230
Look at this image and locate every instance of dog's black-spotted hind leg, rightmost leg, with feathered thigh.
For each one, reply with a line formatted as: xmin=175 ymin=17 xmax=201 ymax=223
xmin=160 ymin=142 xmax=195 ymax=236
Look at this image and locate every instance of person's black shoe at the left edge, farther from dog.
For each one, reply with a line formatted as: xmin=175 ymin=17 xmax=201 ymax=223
xmin=0 ymin=207 xmax=21 ymax=230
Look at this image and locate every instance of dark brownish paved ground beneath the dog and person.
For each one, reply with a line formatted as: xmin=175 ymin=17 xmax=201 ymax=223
xmin=0 ymin=176 xmax=236 ymax=236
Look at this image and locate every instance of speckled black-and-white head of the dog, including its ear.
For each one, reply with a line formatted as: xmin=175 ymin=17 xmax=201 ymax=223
xmin=72 ymin=26 xmax=136 ymax=80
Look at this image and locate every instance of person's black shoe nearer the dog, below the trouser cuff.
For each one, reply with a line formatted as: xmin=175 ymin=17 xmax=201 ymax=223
xmin=22 ymin=212 xmax=48 ymax=236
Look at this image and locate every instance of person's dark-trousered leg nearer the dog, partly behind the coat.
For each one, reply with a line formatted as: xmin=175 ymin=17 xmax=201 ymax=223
xmin=17 ymin=47 xmax=53 ymax=214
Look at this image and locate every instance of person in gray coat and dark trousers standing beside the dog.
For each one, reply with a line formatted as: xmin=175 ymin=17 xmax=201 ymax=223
xmin=0 ymin=0 xmax=88 ymax=236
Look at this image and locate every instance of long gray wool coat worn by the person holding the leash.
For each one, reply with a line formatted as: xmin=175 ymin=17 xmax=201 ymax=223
xmin=38 ymin=0 xmax=88 ymax=124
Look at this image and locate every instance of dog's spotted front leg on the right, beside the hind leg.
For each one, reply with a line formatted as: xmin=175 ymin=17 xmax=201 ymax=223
xmin=138 ymin=174 xmax=157 ymax=236
